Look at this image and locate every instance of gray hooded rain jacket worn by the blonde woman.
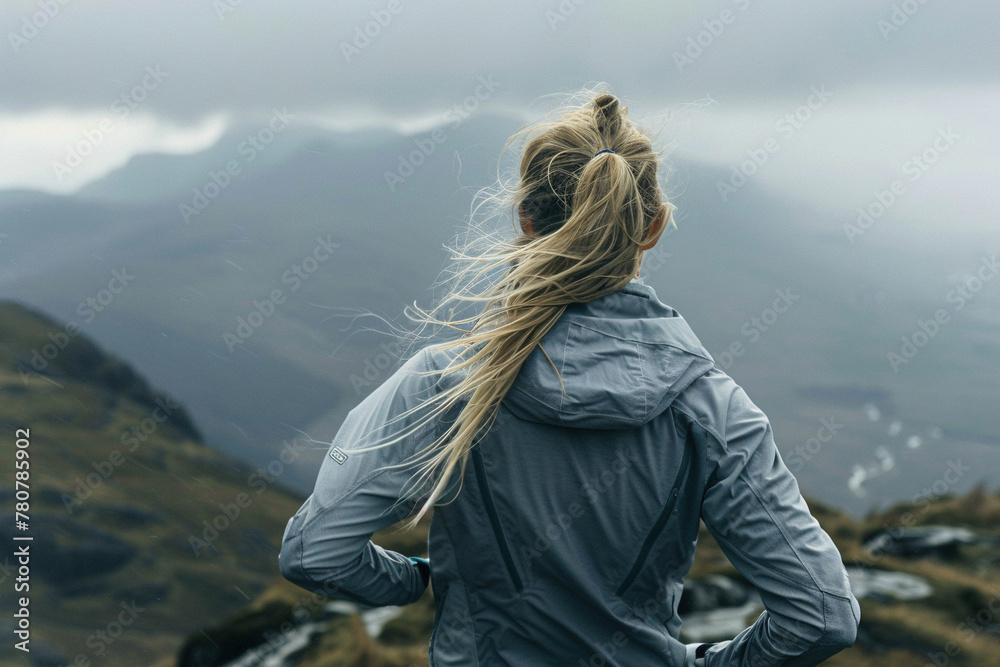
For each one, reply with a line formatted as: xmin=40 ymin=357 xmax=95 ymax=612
xmin=280 ymin=280 xmax=861 ymax=667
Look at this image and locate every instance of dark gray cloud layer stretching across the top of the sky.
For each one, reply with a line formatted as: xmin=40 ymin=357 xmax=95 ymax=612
xmin=0 ymin=0 xmax=1000 ymax=123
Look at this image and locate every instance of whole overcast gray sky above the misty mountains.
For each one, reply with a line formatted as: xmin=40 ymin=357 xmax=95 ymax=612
xmin=0 ymin=0 xmax=1000 ymax=235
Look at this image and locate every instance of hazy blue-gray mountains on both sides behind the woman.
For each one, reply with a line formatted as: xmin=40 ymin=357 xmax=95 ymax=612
xmin=0 ymin=109 xmax=1000 ymax=515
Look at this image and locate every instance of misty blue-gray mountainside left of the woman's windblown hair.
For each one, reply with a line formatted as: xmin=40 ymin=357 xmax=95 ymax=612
xmin=0 ymin=118 xmax=504 ymax=496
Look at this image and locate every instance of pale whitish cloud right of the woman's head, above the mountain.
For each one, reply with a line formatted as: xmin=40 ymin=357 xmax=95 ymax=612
xmin=676 ymin=85 xmax=1000 ymax=238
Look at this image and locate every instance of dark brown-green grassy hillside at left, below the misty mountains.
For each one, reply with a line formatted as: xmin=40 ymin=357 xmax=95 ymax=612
xmin=0 ymin=302 xmax=302 ymax=667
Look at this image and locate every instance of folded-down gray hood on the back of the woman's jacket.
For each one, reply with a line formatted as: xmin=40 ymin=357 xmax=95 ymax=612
xmin=504 ymin=280 xmax=715 ymax=429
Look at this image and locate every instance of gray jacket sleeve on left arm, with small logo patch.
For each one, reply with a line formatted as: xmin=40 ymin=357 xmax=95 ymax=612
xmin=278 ymin=350 xmax=444 ymax=606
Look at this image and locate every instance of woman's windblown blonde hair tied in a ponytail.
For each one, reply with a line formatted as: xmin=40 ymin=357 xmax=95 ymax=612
xmin=360 ymin=86 xmax=673 ymax=528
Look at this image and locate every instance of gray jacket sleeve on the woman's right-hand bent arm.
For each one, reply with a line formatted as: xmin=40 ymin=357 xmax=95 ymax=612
xmin=702 ymin=378 xmax=861 ymax=667
